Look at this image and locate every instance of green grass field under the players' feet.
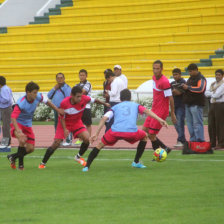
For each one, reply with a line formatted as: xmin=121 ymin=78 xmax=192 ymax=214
xmin=0 ymin=149 xmax=224 ymax=224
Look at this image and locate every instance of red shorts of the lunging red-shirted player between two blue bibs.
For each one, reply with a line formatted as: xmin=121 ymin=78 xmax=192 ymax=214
xmin=54 ymin=119 xmax=87 ymax=139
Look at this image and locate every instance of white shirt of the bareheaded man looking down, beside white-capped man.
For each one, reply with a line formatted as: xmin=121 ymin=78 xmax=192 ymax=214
xmin=108 ymin=77 xmax=126 ymax=102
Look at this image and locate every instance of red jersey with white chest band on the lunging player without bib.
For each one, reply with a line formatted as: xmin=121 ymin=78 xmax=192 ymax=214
xmin=60 ymin=95 xmax=92 ymax=124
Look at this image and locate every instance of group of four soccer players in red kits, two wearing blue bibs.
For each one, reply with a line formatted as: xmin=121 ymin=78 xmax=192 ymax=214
xmin=7 ymin=60 xmax=176 ymax=172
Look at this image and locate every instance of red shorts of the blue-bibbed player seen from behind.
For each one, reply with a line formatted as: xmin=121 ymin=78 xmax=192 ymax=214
xmin=101 ymin=129 xmax=146 ymax=145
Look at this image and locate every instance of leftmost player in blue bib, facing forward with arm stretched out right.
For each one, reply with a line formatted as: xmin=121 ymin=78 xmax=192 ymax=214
xmin=7 ymin=82 xmax=63 ymax=170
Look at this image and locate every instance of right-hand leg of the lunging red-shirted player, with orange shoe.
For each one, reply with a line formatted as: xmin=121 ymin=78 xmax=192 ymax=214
xmin=75 ymin=131 xmax=89 ymax=166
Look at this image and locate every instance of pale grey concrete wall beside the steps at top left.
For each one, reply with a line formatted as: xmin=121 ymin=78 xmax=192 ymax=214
xmin=0 ymin=0 xmax=60 ymax=27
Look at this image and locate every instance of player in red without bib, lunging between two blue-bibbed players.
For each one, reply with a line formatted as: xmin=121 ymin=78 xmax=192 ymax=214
xmin=39 ymin=86 xmax=110 ymax=169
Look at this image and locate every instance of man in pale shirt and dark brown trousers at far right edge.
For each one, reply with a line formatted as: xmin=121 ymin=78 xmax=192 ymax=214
xmin=205 ymin=69 xmax=224 ymax=149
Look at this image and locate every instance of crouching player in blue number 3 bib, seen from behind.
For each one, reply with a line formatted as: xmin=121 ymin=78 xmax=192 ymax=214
xmin=83 ymin=89 xmax=167 ymax=172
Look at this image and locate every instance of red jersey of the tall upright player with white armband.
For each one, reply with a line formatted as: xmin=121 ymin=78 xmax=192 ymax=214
xmin=152 ymin=75 xmax=172 ymax=116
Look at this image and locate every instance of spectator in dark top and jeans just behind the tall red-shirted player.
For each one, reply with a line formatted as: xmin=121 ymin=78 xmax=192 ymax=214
xmin=171 ymin=68 xmax=186 ymax=147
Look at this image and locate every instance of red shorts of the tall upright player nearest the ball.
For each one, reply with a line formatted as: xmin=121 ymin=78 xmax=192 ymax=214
xmin=143 ymin=114 xmax=168 ymax=134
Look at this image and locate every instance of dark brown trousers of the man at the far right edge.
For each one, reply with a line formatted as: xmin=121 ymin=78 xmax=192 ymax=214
xmin=208 ymin=103 xmax=224 ymax=147
